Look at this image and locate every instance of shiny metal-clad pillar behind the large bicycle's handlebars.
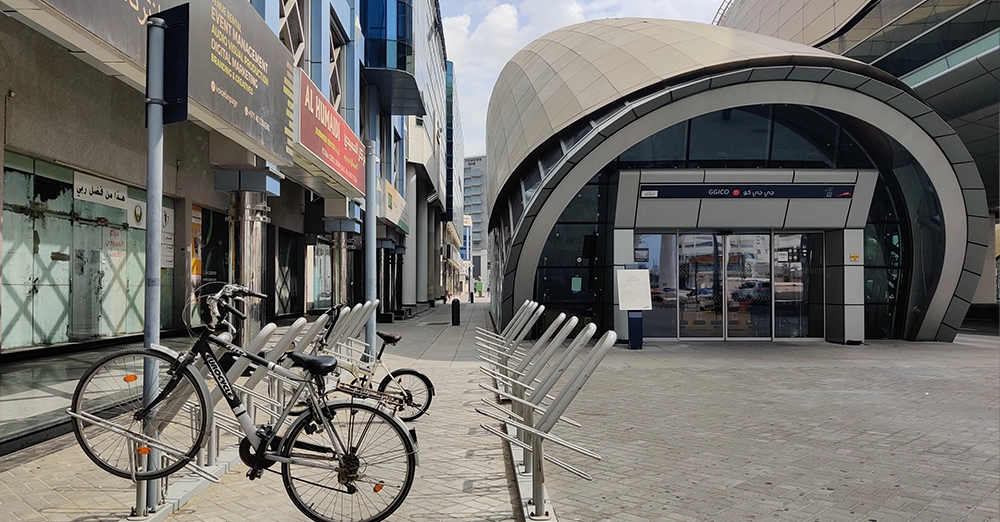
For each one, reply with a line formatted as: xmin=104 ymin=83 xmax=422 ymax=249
xmin=229 ymin=190 xmax=271 ymax=346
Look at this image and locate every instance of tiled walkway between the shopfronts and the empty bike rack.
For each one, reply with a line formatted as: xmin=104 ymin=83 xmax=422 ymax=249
xmin=0 ymin=300 xmax=513 ymax=522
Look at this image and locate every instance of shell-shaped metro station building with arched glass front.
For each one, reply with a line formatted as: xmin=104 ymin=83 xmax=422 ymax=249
xmin=486 ymin=18 xmax=989 ymax=343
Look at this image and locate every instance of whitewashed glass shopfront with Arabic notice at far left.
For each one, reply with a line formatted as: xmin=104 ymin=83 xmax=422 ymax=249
xmin=0 ymin=152 xmax=174 ymax=350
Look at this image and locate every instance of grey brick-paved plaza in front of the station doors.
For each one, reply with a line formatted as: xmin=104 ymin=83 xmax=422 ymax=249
xmin=546 ymin=335 xmax=1000 ymax=522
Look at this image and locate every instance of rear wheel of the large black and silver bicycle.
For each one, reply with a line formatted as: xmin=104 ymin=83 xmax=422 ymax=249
xmin=281 ymin=402 xmax=416 ymax=522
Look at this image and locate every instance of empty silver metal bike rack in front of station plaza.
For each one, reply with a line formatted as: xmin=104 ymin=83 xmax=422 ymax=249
xmin=476 ymin=310 xmax=617 ymax=520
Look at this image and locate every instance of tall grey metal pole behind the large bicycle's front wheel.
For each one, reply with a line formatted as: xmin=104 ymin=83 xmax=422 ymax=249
xmin=142 ymin=18 xmax=167 ymax=509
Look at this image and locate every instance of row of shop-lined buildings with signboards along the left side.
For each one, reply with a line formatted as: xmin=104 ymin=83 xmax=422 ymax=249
xmin=0 ymin=0 xmax=460 ymax=355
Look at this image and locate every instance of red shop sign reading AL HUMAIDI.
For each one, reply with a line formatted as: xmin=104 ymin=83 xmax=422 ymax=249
xmin=292 ymin=69 xmax=365 ymax=197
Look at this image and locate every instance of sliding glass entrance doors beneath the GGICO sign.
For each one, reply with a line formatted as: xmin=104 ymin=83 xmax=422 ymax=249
xmin=635 ymin=232 xmax=824 ymax=340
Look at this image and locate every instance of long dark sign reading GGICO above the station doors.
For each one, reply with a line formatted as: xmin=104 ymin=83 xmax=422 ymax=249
xmin=639 ymin=183 xmax=854 ymax=199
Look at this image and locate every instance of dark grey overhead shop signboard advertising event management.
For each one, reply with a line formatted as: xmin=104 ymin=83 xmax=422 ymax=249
xmin=31 ymin=0 xmax=294 ymax=166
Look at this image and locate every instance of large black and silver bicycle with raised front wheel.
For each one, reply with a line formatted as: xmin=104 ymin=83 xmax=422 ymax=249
xmin=68 ymin=285 xmax=417 ymax=522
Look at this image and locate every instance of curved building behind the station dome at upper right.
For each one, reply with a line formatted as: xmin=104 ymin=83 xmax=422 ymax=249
xmin=715 ymin=0 xmax=1000 ymax=306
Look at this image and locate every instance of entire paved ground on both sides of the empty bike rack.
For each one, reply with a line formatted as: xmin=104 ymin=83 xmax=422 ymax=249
xmin=0 ymin=301 xmax=1000 ymax=522
